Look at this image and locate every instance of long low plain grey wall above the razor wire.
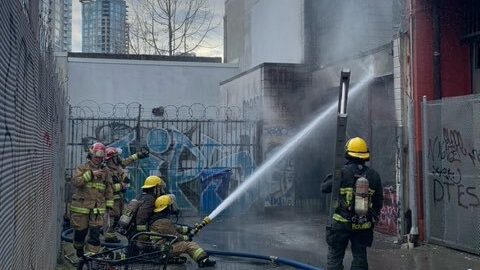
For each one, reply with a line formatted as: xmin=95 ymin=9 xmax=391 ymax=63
xmin=67 ymin=57 xmax=238 ymax=108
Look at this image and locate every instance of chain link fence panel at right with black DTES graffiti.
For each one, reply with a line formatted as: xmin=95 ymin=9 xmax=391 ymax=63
xmin=422 ymin=95 xmax=480 ymax=254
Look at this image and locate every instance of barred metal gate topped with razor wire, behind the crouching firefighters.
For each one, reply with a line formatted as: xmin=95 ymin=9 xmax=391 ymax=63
xmin=66 ymin=104 xmax=261 ymax=212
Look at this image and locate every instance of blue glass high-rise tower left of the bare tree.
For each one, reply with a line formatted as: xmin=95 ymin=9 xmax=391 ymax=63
xmin=80 ymin=0 xmax=128 ymax=54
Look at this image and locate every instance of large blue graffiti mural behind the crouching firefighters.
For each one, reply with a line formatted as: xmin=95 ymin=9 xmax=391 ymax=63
xmin=82 ymin=122 xmax=255 ymax=211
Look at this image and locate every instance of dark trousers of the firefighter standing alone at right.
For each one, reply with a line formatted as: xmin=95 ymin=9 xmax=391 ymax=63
xmin=326 ymin=228 xmax=373 ymax=270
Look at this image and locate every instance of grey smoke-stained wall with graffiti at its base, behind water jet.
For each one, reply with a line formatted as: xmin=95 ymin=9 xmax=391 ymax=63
xmin=220 ymin=63 xmax=309 ymax=207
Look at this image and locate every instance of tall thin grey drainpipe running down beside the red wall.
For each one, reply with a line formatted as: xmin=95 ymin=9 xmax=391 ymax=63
xmin=407 ymin=0 xmax=418 ymax=248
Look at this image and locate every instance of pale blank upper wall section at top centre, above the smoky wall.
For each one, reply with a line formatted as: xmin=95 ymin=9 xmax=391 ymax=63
xmin=224 ymin=0 xmax=304 ymax=71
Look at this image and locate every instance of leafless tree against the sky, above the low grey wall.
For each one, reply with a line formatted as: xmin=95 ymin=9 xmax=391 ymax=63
xmin=129 ymin=0 xmax=221 ymax=55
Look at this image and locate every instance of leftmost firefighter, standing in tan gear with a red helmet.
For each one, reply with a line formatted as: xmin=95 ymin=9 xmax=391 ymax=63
xmin=70 ymin=143 xmax=113 ymax=257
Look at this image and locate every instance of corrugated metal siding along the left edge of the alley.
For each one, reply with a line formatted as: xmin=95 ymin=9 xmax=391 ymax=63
xmin=0 ymin=0 xmax=65 ymax=269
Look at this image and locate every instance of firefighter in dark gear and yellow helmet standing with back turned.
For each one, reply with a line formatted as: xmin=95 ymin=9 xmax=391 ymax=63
xmin=322 ymin=137 xmax=383 ymax=270
